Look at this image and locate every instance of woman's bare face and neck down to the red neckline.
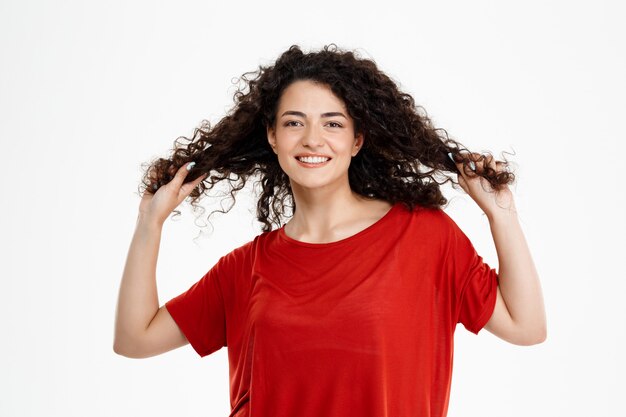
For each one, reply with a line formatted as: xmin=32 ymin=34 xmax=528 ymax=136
xmin=267 ymin=81 xmax=391 ymax=243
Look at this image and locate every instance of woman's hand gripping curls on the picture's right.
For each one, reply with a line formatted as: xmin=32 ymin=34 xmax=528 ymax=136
xmin=455 ymin=153 xmax=515 ymax=218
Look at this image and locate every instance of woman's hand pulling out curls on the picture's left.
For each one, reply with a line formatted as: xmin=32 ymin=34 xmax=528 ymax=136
xmin=138 ymin=162 xmax=208 ymax=226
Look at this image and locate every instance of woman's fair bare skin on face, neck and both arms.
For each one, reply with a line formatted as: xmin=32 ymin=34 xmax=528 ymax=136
xmin=113 ymin=81 xmax=546 ymax=358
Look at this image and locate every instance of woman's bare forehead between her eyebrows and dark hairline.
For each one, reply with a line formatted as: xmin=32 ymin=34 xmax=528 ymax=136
xmin=279 ymin=80 xmax=345 ymax=110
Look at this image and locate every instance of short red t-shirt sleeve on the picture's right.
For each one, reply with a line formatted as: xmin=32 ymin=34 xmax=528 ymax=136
xmin=447 ymin=213 xmax=498 ymax=334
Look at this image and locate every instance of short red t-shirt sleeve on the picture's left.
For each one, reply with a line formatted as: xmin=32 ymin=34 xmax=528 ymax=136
xmin=165 ymin=257 xmax=227 ymax=357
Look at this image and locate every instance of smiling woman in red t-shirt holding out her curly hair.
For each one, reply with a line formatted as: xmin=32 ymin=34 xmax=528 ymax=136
xmin=114 ymin=45 xmax=546 ymax=417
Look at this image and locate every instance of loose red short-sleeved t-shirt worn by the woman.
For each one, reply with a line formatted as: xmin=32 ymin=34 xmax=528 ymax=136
xmin=166 ymin=203 xmax=498 ymax=417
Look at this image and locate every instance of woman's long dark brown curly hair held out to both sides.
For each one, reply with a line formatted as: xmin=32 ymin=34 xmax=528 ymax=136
xmin=140 ymin=44 xmax=515 ymax=232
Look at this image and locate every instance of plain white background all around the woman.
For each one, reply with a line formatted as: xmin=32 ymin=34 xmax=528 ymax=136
xmin=0 ymin=0 xmax=626 ymax=417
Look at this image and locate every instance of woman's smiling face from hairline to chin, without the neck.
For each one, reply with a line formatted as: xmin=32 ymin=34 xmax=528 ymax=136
xmin=267 ymin=80 xmax=363 ymax=191
